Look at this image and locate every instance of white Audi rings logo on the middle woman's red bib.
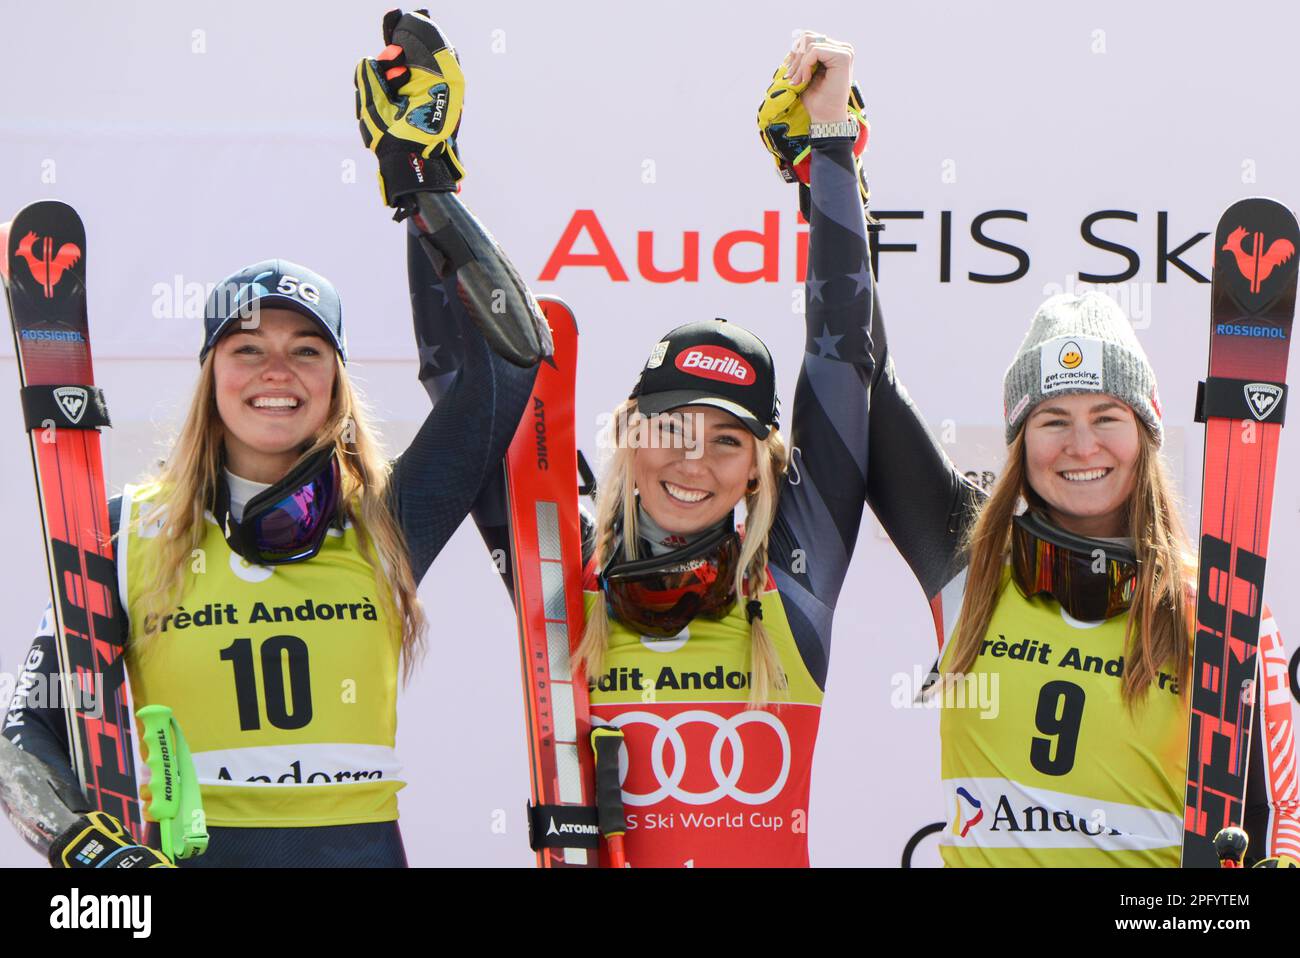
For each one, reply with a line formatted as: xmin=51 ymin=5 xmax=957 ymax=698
xmin=615 ymin=708 xmax=790 ymax=806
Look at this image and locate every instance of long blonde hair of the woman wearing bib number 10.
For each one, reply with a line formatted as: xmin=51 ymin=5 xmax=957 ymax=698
xmin=122 ymin=351 xmax=425 ymax=679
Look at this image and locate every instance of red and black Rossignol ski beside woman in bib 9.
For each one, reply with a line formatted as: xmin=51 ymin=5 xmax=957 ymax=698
xmin=1183 ymin=198 xmax=1300 ymax=868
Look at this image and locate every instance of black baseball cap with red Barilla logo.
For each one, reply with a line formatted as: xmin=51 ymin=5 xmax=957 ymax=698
xmin=632 ymin=320 xmax=777 ymax=439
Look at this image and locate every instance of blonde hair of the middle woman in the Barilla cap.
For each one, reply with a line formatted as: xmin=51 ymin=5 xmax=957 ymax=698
xmin=577 ymin=399 xmax=789 ymax=708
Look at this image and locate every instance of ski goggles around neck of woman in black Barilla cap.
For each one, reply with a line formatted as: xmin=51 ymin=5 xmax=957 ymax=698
xmin=599 ymin=523 xmax=740 ymax=638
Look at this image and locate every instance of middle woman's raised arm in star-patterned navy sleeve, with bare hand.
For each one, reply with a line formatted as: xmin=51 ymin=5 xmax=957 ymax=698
xmin=759 ymin=34 xmax=875 ymax=684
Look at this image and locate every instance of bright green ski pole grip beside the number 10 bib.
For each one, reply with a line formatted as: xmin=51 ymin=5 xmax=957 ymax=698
xmin=135 ymin=706 xmax=208 ymax=862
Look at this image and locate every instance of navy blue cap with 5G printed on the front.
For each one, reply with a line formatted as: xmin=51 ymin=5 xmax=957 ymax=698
xmin=199 ymin=260 xmax=347 ymax=363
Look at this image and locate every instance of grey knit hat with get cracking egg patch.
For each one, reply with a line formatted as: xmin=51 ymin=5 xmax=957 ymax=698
xmin=1002 ymin=292 xmax=1165 ymax=446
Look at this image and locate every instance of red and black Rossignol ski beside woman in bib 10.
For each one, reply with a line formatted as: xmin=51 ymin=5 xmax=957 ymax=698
xmin=0 ymin=201 xmax=144 ymax=844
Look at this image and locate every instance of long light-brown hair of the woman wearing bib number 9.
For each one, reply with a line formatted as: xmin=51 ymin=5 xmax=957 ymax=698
xmin=952 ymin=419 xmax=1195 ymax=708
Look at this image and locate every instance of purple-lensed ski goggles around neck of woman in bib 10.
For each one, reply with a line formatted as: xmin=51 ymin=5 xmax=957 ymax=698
xmin=217 ymin=448 xmax=342 ymax=565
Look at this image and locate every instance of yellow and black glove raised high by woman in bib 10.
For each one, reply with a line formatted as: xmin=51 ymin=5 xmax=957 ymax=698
xmin=354 ymin=10 xmax=465 ymax=208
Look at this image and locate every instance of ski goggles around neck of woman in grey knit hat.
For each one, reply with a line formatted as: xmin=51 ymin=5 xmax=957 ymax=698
xmin=1011 ymin=512 xmax=1138 ymax=623
